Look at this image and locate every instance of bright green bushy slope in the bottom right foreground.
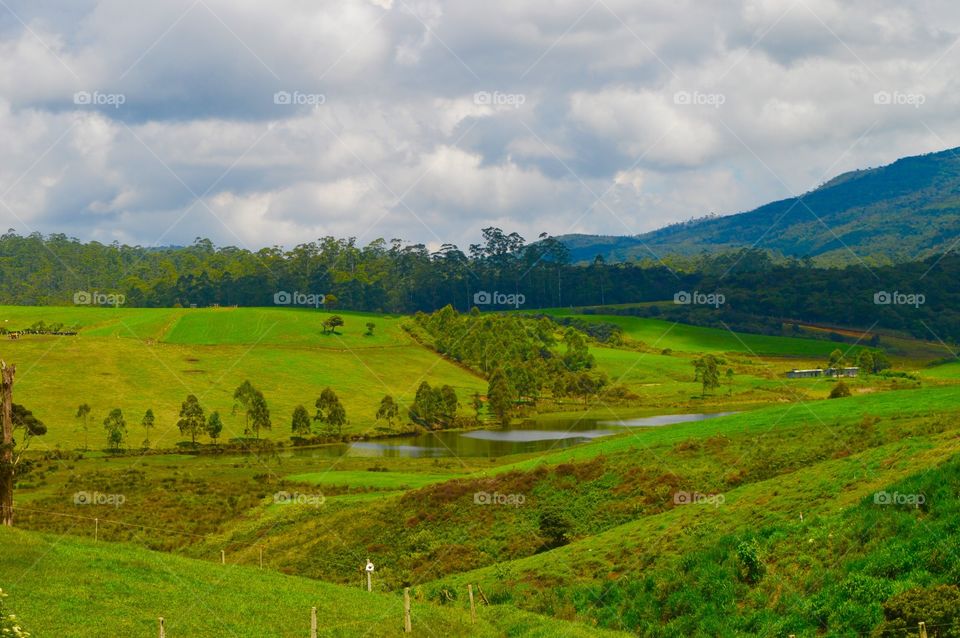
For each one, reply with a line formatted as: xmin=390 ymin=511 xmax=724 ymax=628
xmin=428 ymin=398 xmax=960 ymax=636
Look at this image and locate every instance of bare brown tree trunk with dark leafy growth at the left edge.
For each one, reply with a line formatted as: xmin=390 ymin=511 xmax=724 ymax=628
xmin=0 ymin=360 xmax=47 ymax=527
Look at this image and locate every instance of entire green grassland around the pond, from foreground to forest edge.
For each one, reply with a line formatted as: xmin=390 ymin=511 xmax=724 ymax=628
xmin=0 ymin=308 xmax=960 ymax=638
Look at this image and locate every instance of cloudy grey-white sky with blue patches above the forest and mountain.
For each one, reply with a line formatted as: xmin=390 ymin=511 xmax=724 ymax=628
xmin=0 ymin=0 xmax=960 ymax=249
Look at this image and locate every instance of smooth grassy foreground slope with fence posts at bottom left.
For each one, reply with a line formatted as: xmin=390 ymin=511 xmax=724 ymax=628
xmin=0 ymin=528 xmax=628 ymax=638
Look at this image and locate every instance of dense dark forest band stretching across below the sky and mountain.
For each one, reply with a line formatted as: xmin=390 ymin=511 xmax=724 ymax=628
xmin=0 ymin=228 xmax=960 ymax=343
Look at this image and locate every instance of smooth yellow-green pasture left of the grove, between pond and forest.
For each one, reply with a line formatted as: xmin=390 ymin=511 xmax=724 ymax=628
xmin=0 ymin=306 xmax=486 ymax=448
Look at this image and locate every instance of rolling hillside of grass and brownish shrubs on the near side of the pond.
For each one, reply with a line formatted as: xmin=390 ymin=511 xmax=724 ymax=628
xmin=13 ymin=386 xmax=960 ymax=636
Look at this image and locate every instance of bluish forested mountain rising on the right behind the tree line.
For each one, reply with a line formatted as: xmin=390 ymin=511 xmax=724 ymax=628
xmin=561 ymin=149 xmax=960 ymax=263
